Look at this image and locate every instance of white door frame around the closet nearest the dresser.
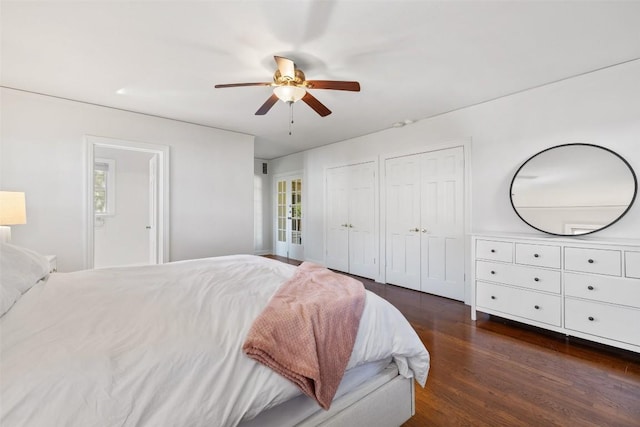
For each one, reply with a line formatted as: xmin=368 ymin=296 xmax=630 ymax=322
xmin=379 ymin=137 xmax=472 ymax=305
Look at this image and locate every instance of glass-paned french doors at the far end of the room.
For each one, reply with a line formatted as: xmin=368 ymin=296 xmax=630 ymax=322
xmin=275 ymin=175 xmax=304 ymax=261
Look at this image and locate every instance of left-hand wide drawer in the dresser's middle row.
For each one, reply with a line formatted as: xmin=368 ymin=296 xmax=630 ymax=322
xmin=476 ymin=261 xmax=561 ymax=294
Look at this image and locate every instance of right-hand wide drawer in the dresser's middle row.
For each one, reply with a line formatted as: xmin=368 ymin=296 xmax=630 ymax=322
xmin=564 ymin=273 xmax=640 ymax=310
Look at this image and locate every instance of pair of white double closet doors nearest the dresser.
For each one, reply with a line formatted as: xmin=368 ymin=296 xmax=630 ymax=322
xmin=386 ymin=147 xmax=464 ymax=301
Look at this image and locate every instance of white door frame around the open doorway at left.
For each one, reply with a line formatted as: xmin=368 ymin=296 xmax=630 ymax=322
xmin=83 ymin=135 xmax=170 ymax=269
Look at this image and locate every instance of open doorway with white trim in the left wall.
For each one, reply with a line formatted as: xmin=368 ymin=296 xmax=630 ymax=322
xmin=86 ymin=136 xmax=169 ymax=268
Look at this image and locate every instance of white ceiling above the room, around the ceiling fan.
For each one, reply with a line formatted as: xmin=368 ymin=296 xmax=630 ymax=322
xmin=0 ymin=0 xmax=640 ymax=159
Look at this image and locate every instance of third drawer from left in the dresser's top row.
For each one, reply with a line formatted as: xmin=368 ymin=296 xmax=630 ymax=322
xmin=564 ymin=248 xmax=622 ymax=276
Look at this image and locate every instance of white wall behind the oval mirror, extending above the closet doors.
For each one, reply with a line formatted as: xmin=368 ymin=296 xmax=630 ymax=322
xmin=271 ymin=61 xmax=640 ymax=298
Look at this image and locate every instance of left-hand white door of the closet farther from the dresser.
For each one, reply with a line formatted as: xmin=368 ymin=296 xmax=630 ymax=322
xmin=325 ymin=167 xmax=349 ymax=272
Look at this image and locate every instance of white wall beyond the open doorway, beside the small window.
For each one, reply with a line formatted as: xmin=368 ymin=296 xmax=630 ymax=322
xmin=94 ymin=147 xmax=153 ymax=268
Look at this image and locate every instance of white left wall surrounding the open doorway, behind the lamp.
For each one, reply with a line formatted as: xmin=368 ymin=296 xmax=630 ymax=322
xmin=0 ymin=88 xmax=254 ymax=271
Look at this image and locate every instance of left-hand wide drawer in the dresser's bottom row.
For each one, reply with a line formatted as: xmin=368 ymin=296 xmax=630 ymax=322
xmin=476 ymin=282 xmax=561 ymax=326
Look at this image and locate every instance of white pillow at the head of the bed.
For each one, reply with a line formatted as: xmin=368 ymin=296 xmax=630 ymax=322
xmin=0 ymin=243 xmax=49 ymax=316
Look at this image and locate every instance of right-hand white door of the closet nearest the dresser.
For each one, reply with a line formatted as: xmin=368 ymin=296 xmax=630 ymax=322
xmin=420 ymin=147 xmax=464 ymax=301
